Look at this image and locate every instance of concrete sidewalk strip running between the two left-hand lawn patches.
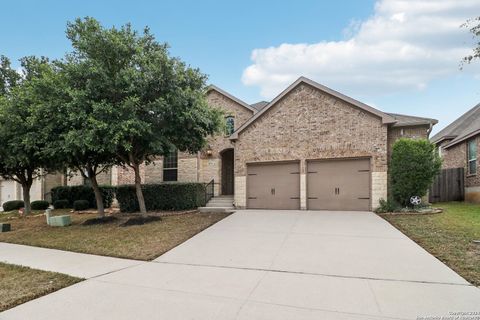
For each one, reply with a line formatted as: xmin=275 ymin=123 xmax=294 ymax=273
xmin=0 ymin=242 xmax=145 ymax=279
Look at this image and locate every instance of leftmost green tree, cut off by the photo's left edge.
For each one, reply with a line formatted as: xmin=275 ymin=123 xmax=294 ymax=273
xmin=0 ymin=57 xmax=58 ymax=214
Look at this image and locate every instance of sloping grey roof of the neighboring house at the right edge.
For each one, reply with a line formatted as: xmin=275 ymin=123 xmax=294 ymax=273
xmin=430 ymin=103 xmax=480 ymax=148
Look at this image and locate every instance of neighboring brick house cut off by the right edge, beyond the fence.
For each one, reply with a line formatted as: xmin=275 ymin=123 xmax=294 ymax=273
xmin=431 ymin=104 xmax=480 ymax=203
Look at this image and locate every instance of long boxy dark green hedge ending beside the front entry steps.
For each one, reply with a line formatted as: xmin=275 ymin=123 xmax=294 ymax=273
xmin=116 ymin=182 xmax=205 ymax=212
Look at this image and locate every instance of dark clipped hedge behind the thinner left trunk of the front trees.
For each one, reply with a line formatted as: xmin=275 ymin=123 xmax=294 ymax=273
xmin=52 ymin=185 xmax=116 ymax=208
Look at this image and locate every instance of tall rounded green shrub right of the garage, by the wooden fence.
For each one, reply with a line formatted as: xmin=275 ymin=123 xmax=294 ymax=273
xmin=390 ymin=138 xmax=442 ymax=206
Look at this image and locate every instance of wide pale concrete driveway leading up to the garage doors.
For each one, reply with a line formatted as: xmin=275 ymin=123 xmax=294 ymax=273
xmin=0 ymin=210 xmax=480 ymax=320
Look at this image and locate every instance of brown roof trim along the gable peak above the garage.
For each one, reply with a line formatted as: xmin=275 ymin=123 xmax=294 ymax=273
xmin=230 ymin=77 xmax=396 ymax=140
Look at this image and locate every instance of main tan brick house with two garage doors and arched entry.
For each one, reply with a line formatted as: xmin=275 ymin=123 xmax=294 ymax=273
xmin=67 ymin=77 xmax=437 ymax=210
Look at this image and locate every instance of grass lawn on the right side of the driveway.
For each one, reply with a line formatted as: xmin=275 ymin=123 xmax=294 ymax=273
xmin=381 ymin=202 xmax=480 ymax=286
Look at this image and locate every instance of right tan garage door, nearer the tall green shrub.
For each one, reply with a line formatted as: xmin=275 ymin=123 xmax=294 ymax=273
xmin=307 ymin=159 xmax=370 ymax=211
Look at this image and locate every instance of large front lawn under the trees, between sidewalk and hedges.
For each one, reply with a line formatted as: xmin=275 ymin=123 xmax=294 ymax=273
xmin=0 ymin=210 xmax=228 ymax=260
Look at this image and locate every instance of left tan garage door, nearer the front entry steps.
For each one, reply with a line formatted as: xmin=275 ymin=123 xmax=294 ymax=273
xmin=247 ymin=162 xmax=300 ymax=209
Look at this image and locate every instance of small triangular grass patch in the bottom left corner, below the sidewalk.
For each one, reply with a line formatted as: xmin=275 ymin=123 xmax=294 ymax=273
xmin=0 ymin=263 xmax=82 ymax=312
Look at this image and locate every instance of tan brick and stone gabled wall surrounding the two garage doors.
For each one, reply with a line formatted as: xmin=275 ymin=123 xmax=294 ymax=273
xmin=235 ymin=84 xmax=388 ymax=208
